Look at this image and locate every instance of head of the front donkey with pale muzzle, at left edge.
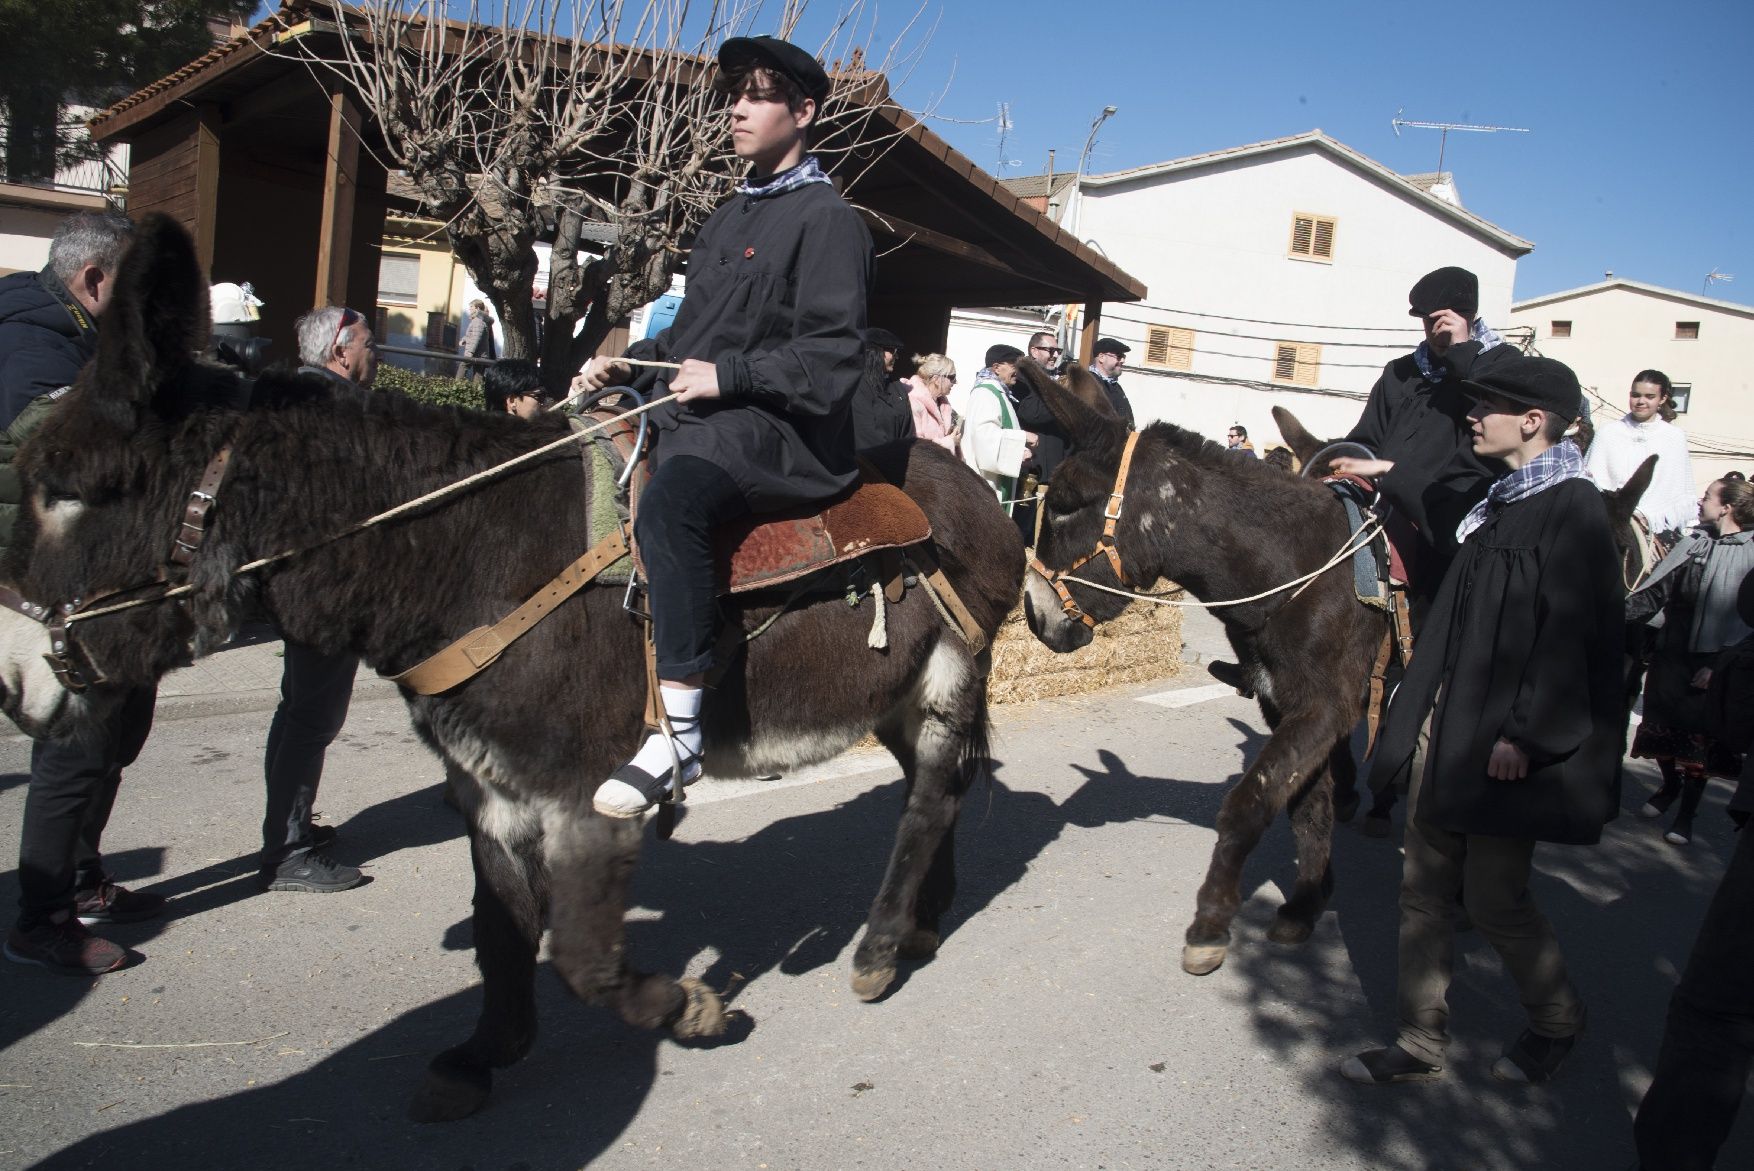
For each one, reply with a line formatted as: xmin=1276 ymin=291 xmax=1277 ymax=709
xmin=0 ymin=216 xmax=247 ymax=735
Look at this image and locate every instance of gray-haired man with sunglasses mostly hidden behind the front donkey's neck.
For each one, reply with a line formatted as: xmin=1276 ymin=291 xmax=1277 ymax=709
xmin=260 ymin=305 xmax=377 ymax=894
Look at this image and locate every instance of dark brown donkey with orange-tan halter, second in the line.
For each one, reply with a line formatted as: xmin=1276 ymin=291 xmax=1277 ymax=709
xmin=1024 ymin=368 xmax=1386 ymax=976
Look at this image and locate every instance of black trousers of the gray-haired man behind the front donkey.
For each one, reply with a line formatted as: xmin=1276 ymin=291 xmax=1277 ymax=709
xmin=261 ymin=638 xmax=360 ymax=868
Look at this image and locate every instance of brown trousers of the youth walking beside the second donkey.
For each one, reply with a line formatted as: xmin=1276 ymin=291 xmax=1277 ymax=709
xmin=1398 ymin=764 xmax=1584 ymax=1066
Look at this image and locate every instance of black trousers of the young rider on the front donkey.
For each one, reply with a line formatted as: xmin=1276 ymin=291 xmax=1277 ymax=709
xmin=633 ymin=456 xmax=749 ymax=680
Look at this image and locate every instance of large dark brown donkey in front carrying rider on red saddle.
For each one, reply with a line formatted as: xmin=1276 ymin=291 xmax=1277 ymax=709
xmin=0 ymin=217 xmax=1023 ymax=1120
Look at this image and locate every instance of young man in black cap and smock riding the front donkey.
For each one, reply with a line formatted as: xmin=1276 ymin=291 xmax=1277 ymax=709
xmin=574 ymin=29 xmax=873 ymax=817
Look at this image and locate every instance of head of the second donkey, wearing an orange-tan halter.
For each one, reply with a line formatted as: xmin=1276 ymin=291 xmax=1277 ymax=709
xmin=1019 ymin=361 xmax=1156 ymax=652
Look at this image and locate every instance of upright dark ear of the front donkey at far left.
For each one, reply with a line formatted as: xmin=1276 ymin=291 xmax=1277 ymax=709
xmin=88 ymin=212 xmax=212 ymax=405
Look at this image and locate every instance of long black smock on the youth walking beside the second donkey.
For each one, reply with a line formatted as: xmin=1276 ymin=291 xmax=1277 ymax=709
xmin=1370 ymin=479 xmax=1626 ymax=845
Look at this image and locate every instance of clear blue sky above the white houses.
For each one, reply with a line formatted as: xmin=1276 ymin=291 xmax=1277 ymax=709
xmin=862 ymin=0 xmax=1754 ymax=303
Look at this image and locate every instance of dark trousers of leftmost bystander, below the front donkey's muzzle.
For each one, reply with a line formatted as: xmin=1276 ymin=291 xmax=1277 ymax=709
xmin=18 ymin=687 xmax=158 ymax=931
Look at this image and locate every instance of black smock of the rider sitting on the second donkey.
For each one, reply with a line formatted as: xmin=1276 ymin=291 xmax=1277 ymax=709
xmin=1345 ymin=342 xmax=1515 ymax=598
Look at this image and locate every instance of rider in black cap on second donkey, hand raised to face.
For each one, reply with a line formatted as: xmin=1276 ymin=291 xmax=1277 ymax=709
xmin=1335 ymin=266 xmax=1515 ymax=613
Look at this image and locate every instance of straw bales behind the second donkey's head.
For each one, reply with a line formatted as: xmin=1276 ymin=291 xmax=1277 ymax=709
xmin=989 ymin=601 xmax=1182 ymax=703
